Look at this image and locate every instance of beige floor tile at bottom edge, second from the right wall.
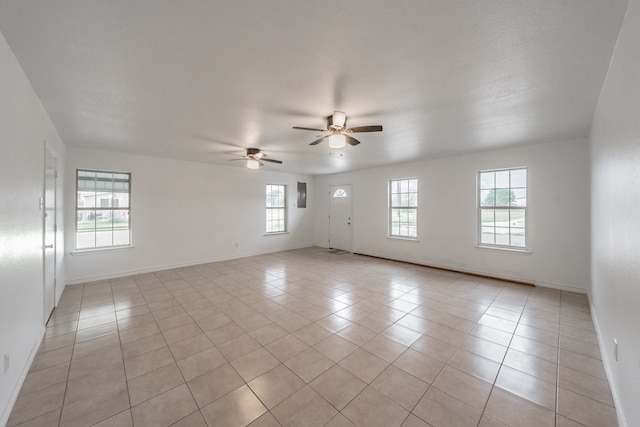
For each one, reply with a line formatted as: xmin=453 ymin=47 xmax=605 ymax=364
xmin=485 ymin=387 xmax=555 ymax=427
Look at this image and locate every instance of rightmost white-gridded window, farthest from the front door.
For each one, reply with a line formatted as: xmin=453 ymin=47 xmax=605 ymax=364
xmin=478 ymin=168 xmax=527 ymax=250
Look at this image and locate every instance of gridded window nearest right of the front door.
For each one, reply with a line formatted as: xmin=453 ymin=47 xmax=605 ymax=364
xmin=389 ymin=178 xmax=418 ymax=239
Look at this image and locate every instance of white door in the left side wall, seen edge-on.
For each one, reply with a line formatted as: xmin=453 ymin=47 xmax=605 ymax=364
xmin=42 ymin=144 xmax=57 ymax=323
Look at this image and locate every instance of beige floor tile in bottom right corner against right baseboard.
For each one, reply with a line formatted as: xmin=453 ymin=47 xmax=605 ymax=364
xmin=558 ymin=387 xmax=617 ymax=426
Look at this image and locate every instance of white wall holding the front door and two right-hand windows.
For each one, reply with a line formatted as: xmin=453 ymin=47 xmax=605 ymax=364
xmin=315 ymin=139 xmax=589 ymax=293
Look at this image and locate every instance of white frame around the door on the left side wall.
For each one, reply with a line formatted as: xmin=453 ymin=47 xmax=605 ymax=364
xmin=40 ymin=140 xmax=58 ymax=325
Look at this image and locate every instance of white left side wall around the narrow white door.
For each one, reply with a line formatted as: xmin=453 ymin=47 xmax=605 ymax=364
xmin=0 ymin=30 xmax=65 ymax=425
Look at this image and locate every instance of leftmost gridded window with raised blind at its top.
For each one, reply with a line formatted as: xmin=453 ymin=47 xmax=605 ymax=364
xmin=76 ymin=169 xmax=131 ymax=249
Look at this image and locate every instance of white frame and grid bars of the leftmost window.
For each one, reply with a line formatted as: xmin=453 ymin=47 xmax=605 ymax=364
xmin=73 ymin=168 xmax=132 ymax=252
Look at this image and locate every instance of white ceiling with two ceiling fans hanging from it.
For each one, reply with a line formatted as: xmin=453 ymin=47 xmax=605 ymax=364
xmin=0 ymin=0 xmax=627 ymax=174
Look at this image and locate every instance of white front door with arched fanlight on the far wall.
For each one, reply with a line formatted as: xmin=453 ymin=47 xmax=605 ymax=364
xmin=329 ymin=185 xmax=351 ymax=252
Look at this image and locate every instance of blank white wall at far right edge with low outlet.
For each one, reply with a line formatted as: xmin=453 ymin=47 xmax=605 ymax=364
xmin=590 ymin=0 xmax=640 ymax=426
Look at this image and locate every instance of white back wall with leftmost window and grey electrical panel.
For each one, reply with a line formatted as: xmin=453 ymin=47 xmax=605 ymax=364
xmin=65 ymin=148 xmax=314 ymax=283
